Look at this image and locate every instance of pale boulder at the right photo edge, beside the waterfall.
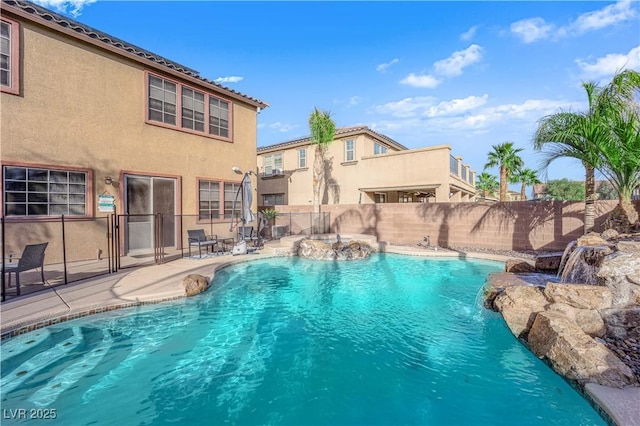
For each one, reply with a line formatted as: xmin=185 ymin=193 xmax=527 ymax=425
xmin=596 ymin=251 xmax=640 ymax=306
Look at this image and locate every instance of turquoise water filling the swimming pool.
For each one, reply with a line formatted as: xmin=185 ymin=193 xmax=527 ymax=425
xmin=1 ymin=254 xmax=604 ymax=425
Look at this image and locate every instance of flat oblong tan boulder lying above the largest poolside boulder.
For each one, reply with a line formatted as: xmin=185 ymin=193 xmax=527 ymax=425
xmin=544 ymin=283 xmax=613 ymax=309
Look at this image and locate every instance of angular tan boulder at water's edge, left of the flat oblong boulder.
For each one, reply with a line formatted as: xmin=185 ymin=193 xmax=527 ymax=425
xmin=494 ymin=286 xmax=549 ymax=338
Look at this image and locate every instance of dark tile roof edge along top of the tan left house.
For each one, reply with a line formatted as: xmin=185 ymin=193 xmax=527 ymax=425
xmin=2 ymin=0 xmax=269 ymax=108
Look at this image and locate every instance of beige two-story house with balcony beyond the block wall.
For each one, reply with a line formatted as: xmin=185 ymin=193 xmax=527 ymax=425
xmin=257 ymin=126 xmax=476 ymax=206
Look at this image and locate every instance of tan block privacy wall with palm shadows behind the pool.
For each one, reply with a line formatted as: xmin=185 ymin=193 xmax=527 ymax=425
xmin=268 ymin=201 xmax=640 ymax=251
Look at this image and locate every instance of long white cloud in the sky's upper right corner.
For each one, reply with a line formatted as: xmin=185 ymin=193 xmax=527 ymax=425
xmin=511 ymin=0 xmax=637 ymax=43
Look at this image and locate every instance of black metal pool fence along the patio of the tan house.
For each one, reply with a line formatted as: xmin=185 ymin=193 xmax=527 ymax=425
xmin=0 ymin=213 xmax=330 ymax=301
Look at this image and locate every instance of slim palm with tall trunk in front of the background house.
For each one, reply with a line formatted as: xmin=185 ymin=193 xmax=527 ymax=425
xmin=309 ymin=107 xmax=336 ymax=213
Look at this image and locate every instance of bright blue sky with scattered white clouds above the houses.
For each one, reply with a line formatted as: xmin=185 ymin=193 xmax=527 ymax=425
xmin=38 ymin=0 xmax=640 ymax=186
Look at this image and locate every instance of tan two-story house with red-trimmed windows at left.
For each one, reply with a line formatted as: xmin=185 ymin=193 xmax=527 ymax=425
xmin=0 ymin=0 xmax=268 ymax=253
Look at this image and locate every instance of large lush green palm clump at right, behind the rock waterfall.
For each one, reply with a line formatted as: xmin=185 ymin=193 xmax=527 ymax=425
xmin=533 ymin=70 xmax=640 ymax=233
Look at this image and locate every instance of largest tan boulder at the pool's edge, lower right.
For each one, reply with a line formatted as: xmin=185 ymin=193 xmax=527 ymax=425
xmin=528 ymin=311 xmax=637 ymax=388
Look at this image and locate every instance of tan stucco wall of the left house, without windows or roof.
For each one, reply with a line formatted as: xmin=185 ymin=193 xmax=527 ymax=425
xmin=0 ymin=14 xmax=257 ymax=260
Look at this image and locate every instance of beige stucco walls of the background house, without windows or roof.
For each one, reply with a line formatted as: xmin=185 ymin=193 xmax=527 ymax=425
xmin=258 ymin=134 xmax=474 ymax=205
